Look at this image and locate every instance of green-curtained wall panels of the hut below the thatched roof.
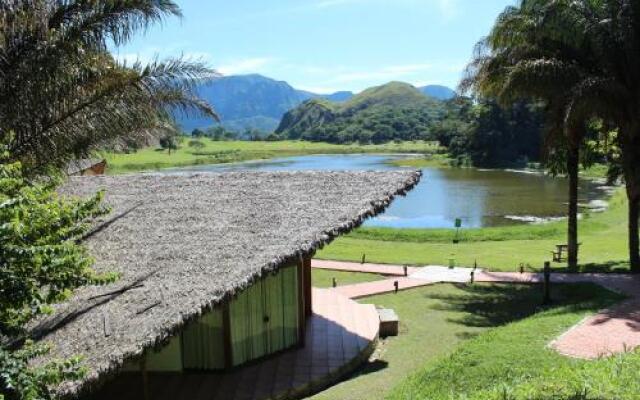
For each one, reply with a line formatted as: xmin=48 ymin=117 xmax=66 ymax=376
xmin=133 ymin=266 xmax=299 ymax=372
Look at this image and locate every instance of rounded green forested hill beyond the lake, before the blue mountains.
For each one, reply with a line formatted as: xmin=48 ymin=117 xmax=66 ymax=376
xmin=276 ymin=82 xmax=445 ymax=143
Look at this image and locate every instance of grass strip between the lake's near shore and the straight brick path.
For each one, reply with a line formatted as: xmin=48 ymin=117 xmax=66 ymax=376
xmin=316 ymin=190 xmax=628 ymax=271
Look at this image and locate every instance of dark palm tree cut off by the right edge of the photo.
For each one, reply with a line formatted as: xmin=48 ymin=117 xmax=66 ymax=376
xmin=496 ymin=0 xmax=640 ymax=272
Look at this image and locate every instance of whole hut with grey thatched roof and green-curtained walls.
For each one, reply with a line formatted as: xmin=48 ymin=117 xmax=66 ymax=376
xmin=33 ymin=171 xmax=420 ymax=399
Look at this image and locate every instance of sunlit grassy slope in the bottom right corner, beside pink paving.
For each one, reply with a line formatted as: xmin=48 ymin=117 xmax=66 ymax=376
xmin=389 ymin=285 xmax=640 ymax=400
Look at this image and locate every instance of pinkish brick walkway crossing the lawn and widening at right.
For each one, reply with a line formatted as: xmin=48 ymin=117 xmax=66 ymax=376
xmin=312 ymin=260 xmax=640 ymax=359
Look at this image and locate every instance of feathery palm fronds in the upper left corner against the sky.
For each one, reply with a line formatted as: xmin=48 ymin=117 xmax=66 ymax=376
xmin=0 ymin=0 xmax=217 ymax=173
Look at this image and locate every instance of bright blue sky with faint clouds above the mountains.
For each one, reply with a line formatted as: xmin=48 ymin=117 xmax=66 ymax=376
xmin=114 ymin=0 xmax=514 ymax=93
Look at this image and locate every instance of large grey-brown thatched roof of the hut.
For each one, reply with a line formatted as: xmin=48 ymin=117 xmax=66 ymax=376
xmin=32 ymin=171 xmax=420 ymax=394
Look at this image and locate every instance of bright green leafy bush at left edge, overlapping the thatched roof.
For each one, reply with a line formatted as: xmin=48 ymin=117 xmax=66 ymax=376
xmin=0 ymin=163 xmax=113 ymax=336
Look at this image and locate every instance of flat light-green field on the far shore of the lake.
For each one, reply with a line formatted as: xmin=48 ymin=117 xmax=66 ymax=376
xmin=103 ymin=138 xmax=441 ymax=174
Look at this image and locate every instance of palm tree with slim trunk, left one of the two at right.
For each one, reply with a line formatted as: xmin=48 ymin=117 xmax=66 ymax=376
xmin=461 ymin=0 xmax=588 ymax=269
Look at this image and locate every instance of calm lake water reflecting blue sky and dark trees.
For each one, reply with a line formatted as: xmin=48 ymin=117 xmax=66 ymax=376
xmin=167 ymin=155 xmax=605 ymax=228
